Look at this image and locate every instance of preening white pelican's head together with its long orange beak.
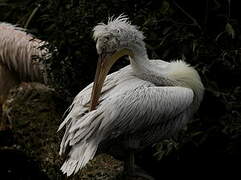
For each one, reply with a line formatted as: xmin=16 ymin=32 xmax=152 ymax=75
xmin=90 ymin=15 xmax=145 ymax=110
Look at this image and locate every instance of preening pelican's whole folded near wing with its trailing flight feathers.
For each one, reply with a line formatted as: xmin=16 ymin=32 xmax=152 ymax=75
xmin=62 ymin=85 xmax=194 ymax=149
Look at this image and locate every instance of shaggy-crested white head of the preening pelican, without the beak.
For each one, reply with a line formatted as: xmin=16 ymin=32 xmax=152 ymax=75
xmin=93 ymin=15 xmax=144 ymax=54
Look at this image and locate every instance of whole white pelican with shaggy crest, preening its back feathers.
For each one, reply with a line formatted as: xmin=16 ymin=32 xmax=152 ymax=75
xmin=59 ymin=15 xmax=204 ymax=179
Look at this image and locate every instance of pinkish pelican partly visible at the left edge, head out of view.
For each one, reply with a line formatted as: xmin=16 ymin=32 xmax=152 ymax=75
xmin=0 ymin=22 xmax=49 ymax=114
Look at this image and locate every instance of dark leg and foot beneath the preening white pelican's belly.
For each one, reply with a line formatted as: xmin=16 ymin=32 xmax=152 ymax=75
xmin=124 ymin=149 xmax=155 ymax=180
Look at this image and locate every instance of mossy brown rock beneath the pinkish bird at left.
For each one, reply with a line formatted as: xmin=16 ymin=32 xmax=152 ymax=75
xmin=1 ymin=83 xmax=63 ymax=179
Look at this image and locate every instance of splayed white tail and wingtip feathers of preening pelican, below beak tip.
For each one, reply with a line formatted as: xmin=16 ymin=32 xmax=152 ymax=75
xmin=60 ymin=108 xmax=104 ymax=176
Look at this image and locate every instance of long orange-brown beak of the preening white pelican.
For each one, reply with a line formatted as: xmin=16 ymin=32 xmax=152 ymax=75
xmin=90 ymin=49 xmax=133 ymax=111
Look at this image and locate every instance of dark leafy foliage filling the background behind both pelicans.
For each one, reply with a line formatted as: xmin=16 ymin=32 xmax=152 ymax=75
xmin=0 ymin=0 xmax=241 ymax=179
